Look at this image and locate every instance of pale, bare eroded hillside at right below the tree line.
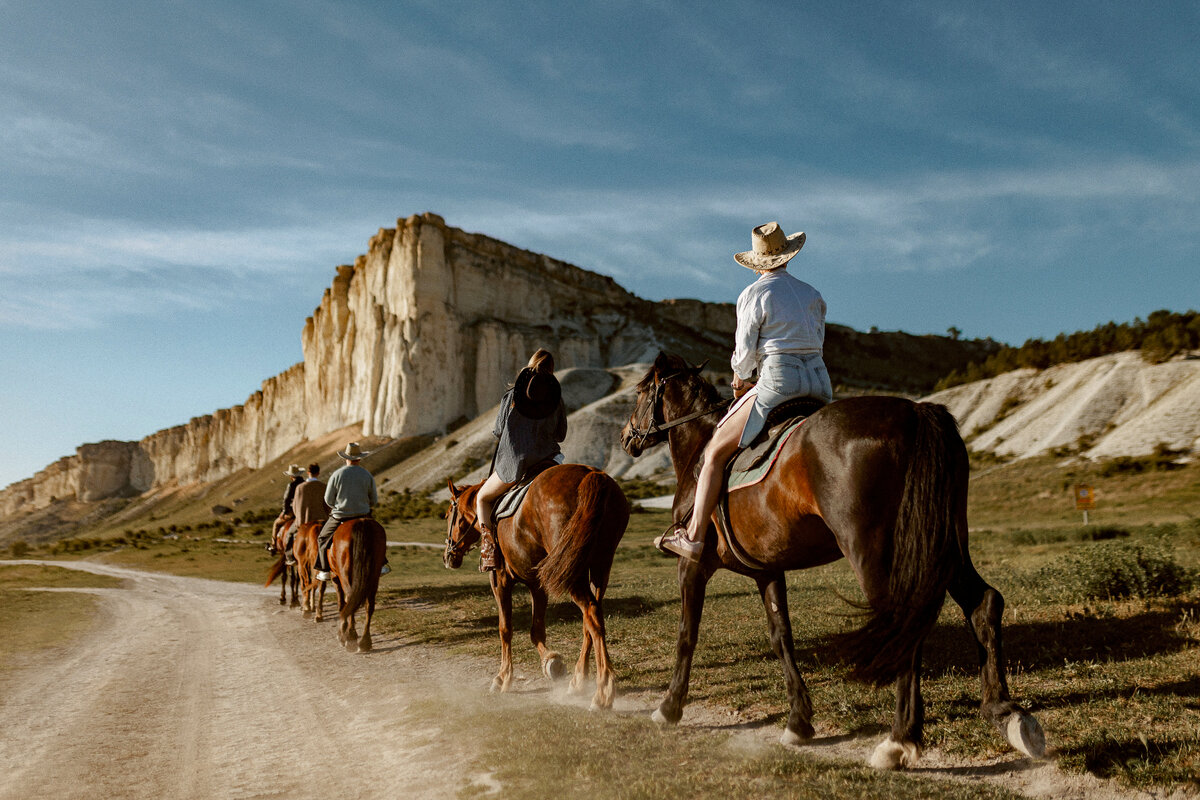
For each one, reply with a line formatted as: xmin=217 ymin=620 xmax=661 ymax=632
xmin=929 ymin=351 xmax=1200 ymax=458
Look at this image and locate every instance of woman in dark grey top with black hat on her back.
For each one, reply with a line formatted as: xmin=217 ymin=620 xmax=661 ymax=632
xmin=475 ymin=349 xmax=566 ymax=572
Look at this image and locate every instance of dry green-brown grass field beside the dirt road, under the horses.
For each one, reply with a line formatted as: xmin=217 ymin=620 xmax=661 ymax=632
xmin=0 ymin=458 xmax=1200 ymax=798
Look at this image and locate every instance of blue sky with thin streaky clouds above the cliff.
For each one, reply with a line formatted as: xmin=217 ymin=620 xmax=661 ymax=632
xmin=0 ymin=0 xmax=1200 ymax=486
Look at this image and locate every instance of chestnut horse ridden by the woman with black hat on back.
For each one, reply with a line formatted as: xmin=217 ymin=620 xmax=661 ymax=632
xmin=442 ymin=464 xmax=629 ymax=709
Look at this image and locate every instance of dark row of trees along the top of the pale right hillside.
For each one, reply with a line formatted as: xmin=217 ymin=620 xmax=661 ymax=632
xmin=936 ymin=309 xmax=1200 ymax=391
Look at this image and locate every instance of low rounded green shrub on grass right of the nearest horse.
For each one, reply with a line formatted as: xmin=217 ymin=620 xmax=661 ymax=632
xmin=1027 ymin=542 xmax=1198 ymax=602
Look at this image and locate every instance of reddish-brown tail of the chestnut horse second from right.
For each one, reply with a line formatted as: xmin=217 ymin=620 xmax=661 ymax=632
xmin=538 ymin=470 xmax=629 ymax=597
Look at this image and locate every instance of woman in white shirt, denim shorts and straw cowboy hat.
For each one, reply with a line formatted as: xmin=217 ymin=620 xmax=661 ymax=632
xmin=655 ymin=222 xmax=833 ymax=559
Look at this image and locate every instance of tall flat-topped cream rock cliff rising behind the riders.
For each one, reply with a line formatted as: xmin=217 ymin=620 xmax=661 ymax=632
xmin=0 ymin=213 xmax=996 ymax=519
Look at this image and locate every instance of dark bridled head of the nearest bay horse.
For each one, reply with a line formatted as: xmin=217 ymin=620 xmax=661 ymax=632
xmin=620 ymin=353 xmax=716 ymax=458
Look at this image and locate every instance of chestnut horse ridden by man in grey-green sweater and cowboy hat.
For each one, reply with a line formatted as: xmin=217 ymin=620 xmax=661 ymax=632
xmin=326 ymin=517 xmax=388 ymax=652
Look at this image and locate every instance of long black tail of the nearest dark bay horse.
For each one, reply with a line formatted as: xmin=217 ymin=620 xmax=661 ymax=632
xmin=845 ymin=403 xmax=968 ymax=686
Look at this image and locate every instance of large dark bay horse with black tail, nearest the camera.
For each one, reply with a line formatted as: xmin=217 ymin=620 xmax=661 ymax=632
xmin=620 ymin=354 xmax=1045 ymax=769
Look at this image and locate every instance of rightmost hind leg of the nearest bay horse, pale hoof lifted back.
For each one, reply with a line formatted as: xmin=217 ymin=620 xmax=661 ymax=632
xmin=950 ymin=560 xmax=1045 ymax=758
